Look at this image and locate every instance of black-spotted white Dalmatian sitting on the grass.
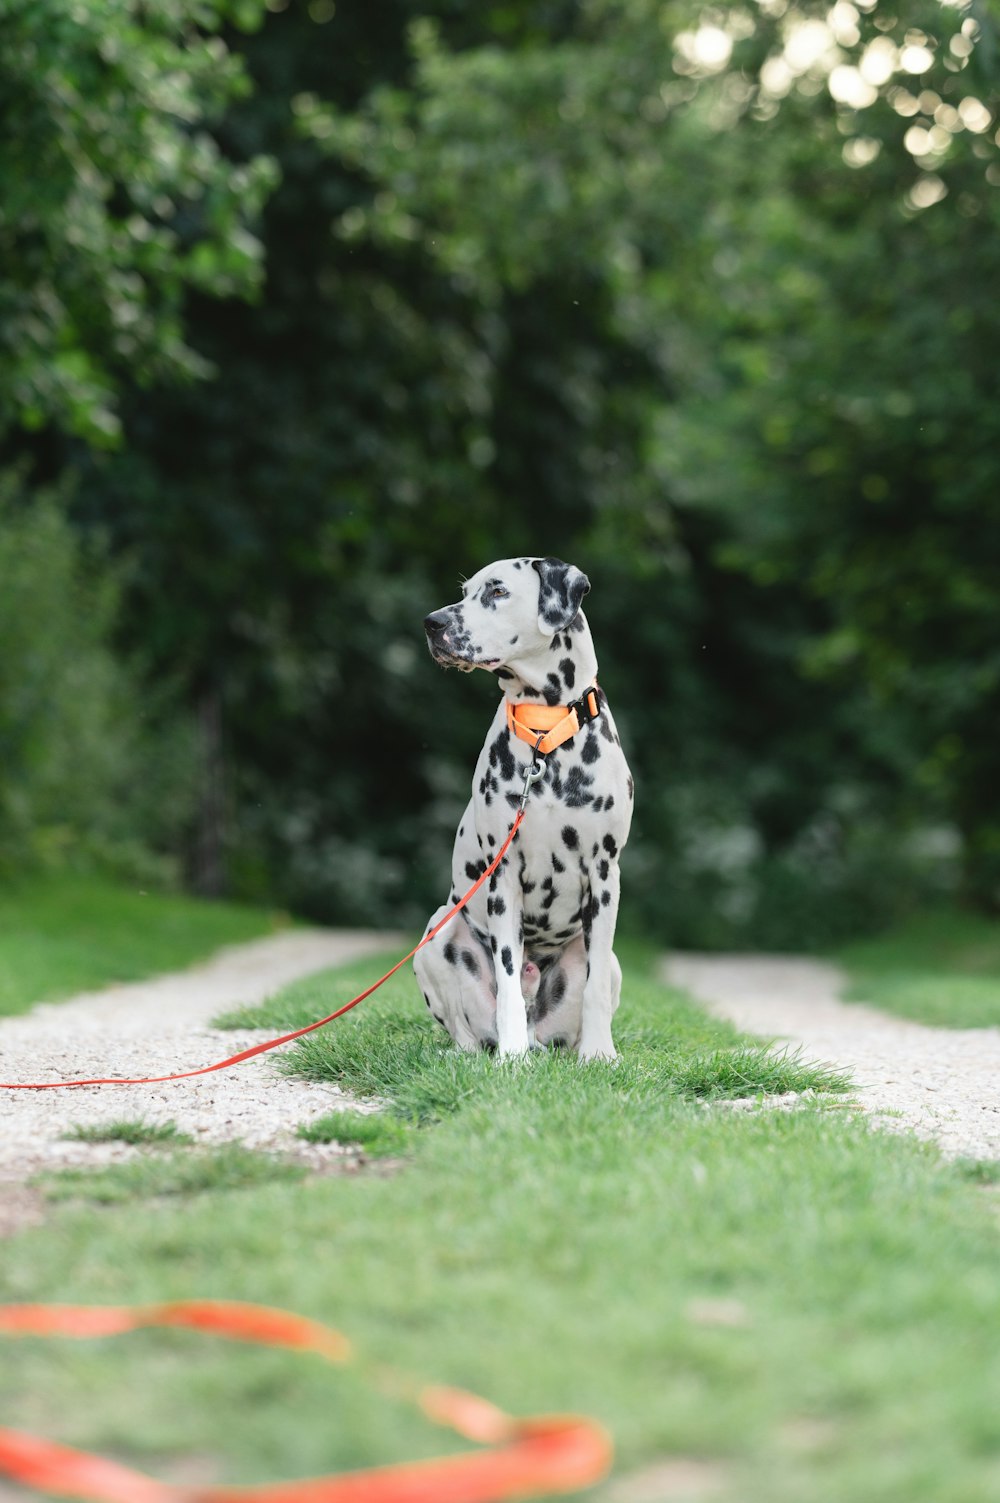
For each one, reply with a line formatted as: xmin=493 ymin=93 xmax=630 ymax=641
xmin=414 ymin=558 xmax=633 ymax=1060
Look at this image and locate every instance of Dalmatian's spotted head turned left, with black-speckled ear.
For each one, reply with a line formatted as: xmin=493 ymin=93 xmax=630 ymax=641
xmin=424 ymin=558 xmax=591 ymax=673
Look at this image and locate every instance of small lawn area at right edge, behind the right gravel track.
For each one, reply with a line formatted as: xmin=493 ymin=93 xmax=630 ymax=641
xmin=835 ymin=911 xmax=1000 ymax=1028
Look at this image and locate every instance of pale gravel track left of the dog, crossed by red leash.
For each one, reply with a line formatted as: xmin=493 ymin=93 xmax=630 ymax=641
xmin=0 ymin=929 xmax=402 ymax=1202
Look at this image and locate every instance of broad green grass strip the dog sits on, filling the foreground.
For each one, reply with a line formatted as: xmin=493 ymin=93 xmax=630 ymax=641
xmin=0 ymin=954 xmax=1000 ymax=1503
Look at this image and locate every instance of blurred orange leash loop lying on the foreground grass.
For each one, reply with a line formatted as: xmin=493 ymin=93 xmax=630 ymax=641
xmin=0 ymin=1300 xmax=612 ymax=1503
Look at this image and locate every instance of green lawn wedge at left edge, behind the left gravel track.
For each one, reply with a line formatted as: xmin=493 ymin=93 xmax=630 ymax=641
xmin=0 ymin=876 xmax=289 ymax=1016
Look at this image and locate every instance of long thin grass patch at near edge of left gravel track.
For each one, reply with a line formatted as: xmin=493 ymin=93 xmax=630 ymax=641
xmin=36 ymin=1139 xmax=305 ymax=1205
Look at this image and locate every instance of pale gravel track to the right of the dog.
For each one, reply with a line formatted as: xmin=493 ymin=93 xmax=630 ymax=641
xmin=663 ymin=954 xmax=1000 ymax=1159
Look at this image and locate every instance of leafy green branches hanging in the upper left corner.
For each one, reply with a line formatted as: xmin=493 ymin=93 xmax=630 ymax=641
xmin=0 ymin=0 xmax=274 ymax=446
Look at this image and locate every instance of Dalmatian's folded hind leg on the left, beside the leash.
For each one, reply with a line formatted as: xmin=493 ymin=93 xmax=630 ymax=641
xmin=414 ymin=905 xmax=496 ymax=1051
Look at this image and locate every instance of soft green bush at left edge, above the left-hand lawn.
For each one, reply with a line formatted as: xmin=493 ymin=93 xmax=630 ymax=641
xmin=0 ymin=472 xmax=198 ymax=881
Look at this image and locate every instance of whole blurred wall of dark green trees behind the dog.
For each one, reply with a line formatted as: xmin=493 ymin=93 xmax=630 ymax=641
xmin=0 ymin=0 xmax=1000 ymax=948
